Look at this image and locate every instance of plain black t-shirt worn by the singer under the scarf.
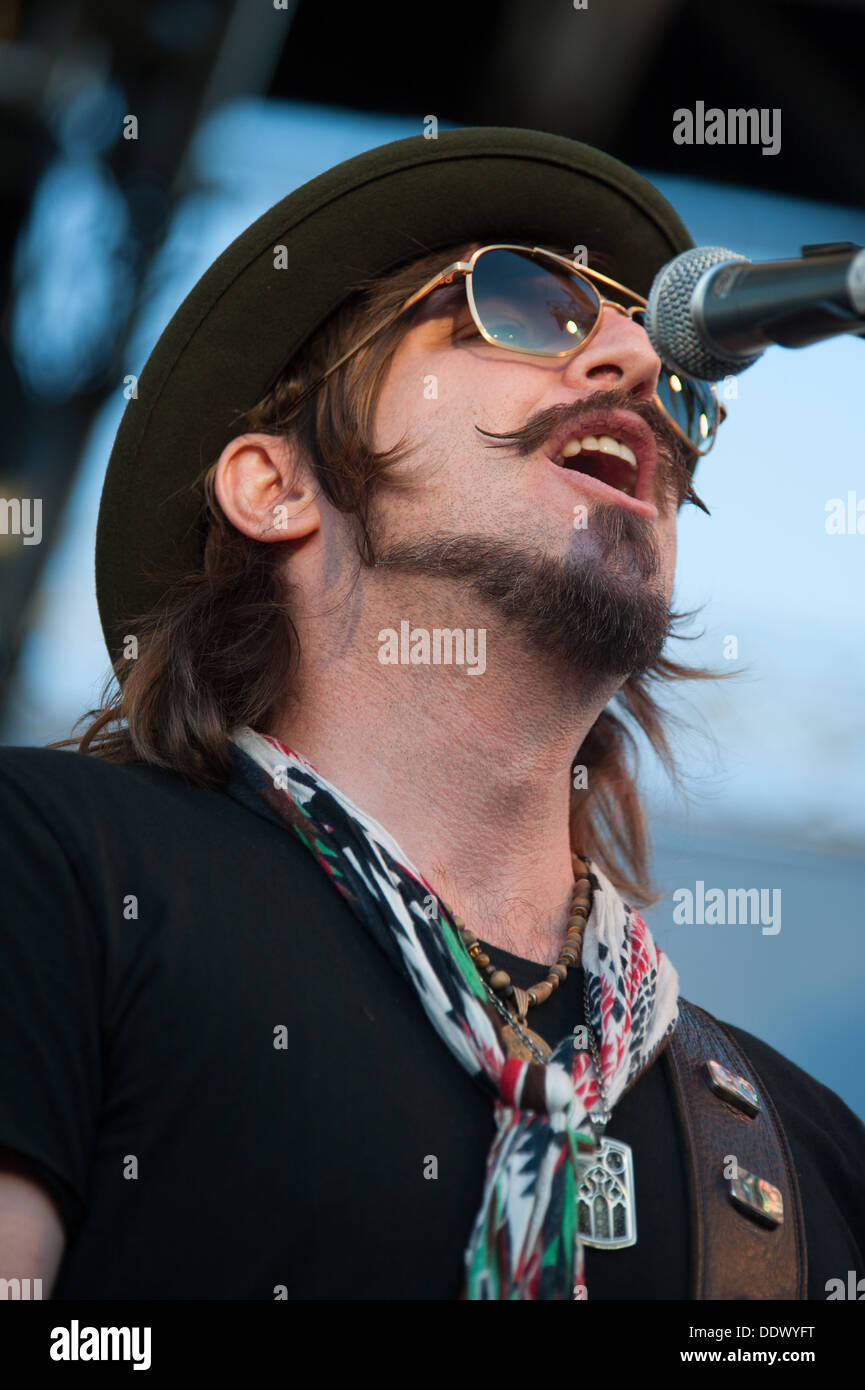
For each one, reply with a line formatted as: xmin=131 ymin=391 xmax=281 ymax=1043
xmin=0 ymin=748 xmax=865 ymax=1300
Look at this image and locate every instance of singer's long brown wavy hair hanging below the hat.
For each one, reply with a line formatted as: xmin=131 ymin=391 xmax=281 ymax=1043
xmin=50 ymin=245 xmax=737 ymax=905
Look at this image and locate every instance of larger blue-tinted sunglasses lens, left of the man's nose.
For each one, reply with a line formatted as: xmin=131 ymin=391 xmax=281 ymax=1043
xmin=471 ymin=250 xmax=601 ymax=354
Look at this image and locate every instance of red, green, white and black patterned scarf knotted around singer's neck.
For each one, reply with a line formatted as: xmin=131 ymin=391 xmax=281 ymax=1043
xmin=228 ymin=728 xmax=679 ymax=1300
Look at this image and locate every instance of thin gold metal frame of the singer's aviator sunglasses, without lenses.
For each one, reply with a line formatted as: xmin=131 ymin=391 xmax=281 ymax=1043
xmin=279 ymin=242 xmax=727 ymax=459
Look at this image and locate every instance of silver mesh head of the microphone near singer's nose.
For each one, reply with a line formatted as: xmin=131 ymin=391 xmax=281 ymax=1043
xmin=645 ymin=246 xmax=762 ymax=381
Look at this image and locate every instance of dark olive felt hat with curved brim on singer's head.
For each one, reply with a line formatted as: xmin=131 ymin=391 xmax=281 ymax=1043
xmin=96 ymin=126 xmax=694 ymax=659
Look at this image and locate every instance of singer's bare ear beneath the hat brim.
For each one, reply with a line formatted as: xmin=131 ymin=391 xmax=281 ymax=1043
xmin=214 ymin=434 xmax=321 ymax=541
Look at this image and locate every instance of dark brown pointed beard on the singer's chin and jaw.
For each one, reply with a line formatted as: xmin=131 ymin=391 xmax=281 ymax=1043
xmin=374 ymin=502 xmax=670 ymax=680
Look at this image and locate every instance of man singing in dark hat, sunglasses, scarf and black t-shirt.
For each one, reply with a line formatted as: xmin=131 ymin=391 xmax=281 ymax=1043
xmin=0 ymin=128 xmax=865 ymax=1300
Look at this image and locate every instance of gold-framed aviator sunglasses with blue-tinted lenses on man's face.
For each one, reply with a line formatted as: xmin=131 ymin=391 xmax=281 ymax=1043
xmin=285 ymin=243 xmax=726 ymax=456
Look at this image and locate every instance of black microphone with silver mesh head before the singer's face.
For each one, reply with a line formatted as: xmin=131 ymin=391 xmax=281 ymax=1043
xmin=645 ymin=242 xmax=865 ymax=381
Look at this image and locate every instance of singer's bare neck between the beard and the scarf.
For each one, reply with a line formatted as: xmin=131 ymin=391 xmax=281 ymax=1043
xmin=266 ymin=581 xmax=617 ymax=965
